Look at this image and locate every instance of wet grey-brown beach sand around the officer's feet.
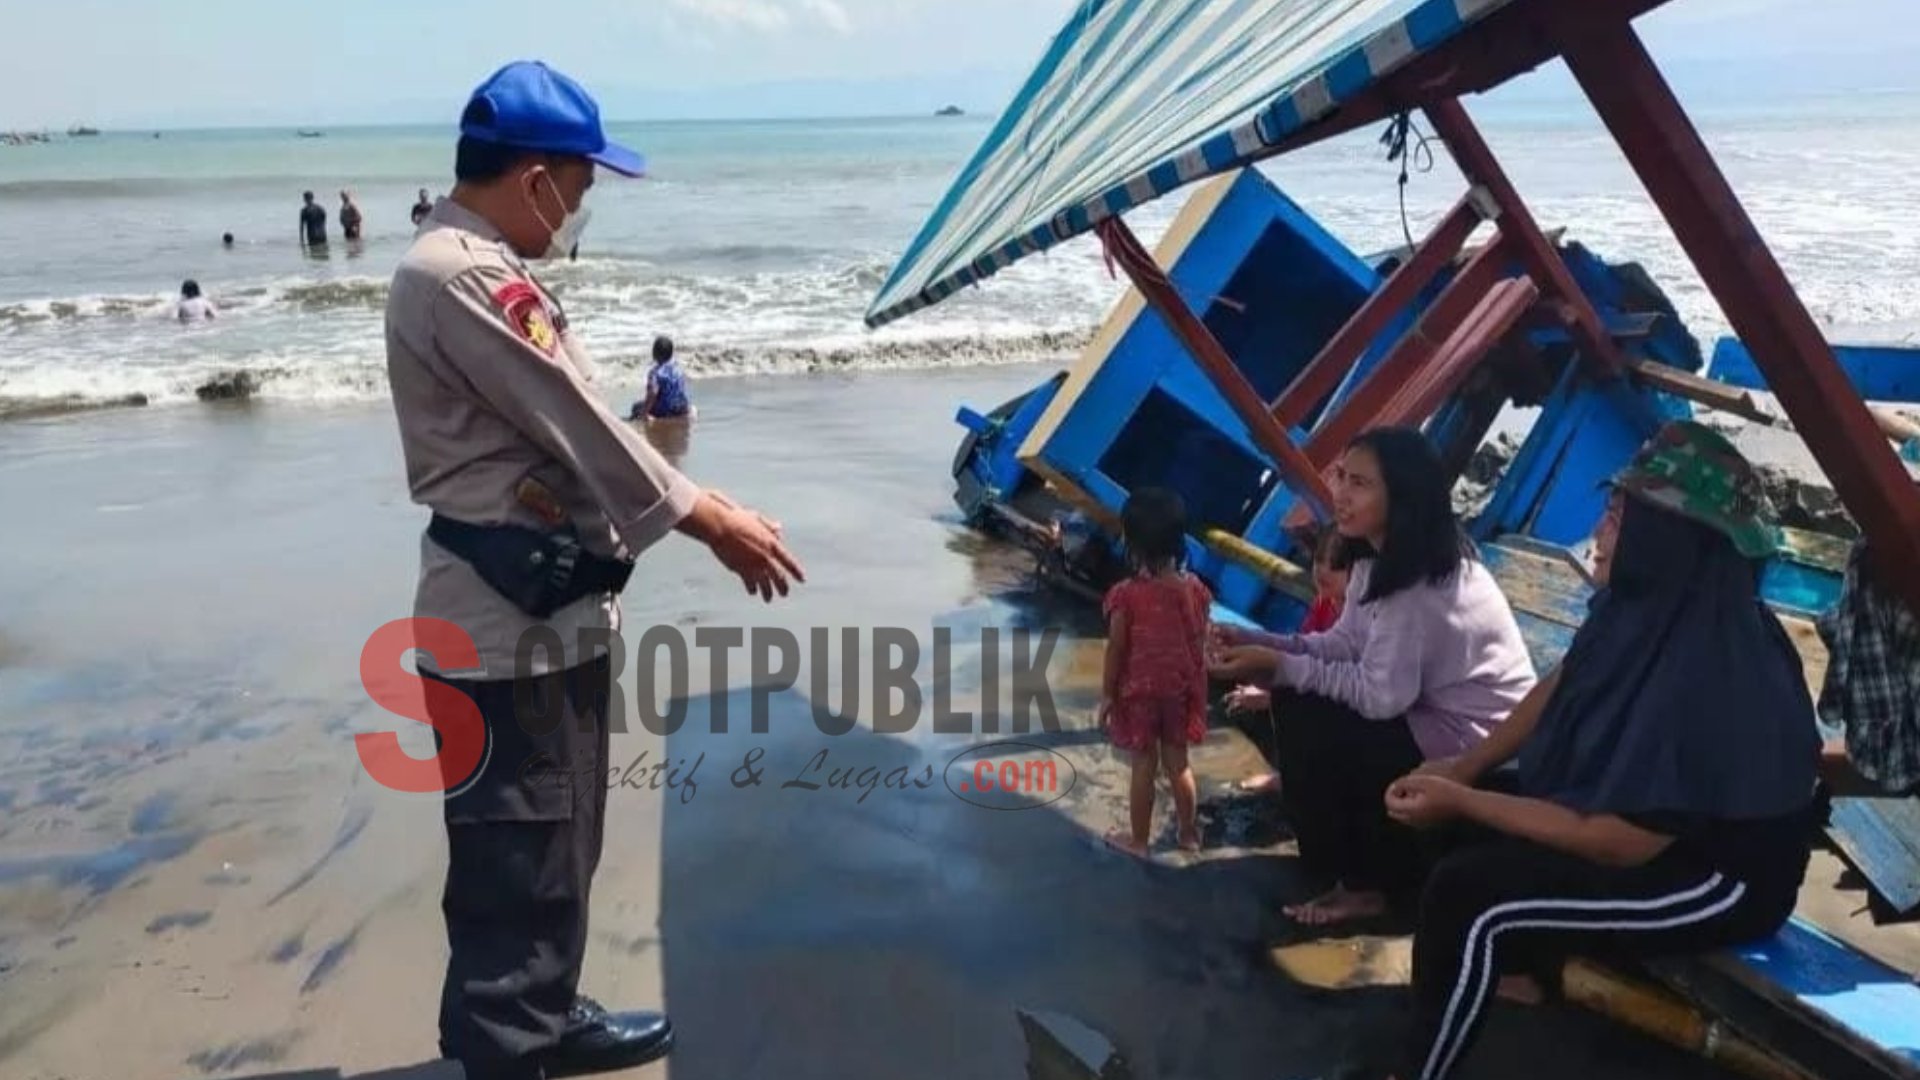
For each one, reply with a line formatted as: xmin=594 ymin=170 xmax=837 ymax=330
xmin=0 ymin=369 xmax=1743 ymax=1080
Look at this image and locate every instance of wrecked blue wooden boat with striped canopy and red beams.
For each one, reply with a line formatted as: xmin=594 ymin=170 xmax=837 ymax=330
xmin=868 ymin=0 xmax=1920 ymax=1078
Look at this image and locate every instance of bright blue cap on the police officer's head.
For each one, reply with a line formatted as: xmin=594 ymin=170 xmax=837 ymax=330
xmin=461 ymin=60 xmax=647 ymax=177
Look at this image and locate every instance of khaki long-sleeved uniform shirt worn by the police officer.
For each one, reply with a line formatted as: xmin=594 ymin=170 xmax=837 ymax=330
xmin=386 ymin=200 xmax=701 ymax=678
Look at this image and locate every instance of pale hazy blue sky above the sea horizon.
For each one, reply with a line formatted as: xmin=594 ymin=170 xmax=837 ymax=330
xmin=0 ymin=0 xmax=1920 ymax=129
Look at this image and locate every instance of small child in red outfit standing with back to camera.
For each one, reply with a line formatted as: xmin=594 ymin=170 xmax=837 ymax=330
xmin=1100 ymin=488 xmax=1212 ymax=855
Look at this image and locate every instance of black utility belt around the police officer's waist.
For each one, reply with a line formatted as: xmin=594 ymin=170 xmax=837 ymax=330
xmin=426 ymin=513 xmax=634 ymax=619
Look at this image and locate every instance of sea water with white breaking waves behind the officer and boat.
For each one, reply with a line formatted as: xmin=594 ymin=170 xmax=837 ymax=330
xmin=0 ymin=98 xmax=1920 ymax=415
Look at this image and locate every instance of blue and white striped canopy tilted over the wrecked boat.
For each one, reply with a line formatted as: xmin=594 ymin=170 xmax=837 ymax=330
xmin=866 ymin=0 xmax=1511 ymax=327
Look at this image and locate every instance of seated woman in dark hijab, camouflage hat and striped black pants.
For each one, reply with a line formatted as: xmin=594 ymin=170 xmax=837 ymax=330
xmin=1386 ymin=423 xmax=1820 ymax=1080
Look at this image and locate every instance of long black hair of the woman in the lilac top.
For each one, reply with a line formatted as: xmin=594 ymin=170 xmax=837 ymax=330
xmin=1346 ymin=427 xmax=1480 ymax=603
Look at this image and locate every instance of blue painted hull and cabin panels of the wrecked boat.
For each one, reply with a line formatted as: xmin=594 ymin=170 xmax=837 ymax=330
xmin=954 ymin=171 xmax=1841 ymax=630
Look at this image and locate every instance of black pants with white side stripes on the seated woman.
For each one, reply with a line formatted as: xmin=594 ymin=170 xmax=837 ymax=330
xmin=1400 ymin=838 xmax=1795 ymax=1080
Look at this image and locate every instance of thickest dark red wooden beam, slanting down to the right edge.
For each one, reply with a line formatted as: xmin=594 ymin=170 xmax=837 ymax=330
xmin=1567 ymin=21 xmax=1920 ymax=611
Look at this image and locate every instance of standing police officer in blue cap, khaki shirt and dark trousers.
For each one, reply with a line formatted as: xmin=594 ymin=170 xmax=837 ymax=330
xmin=386 ymin=61 xmax=804 ymax=1080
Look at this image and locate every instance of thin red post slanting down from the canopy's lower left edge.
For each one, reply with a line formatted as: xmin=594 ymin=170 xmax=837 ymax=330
xmin=1094 ymin=217 xmax=1332 ymax=517
